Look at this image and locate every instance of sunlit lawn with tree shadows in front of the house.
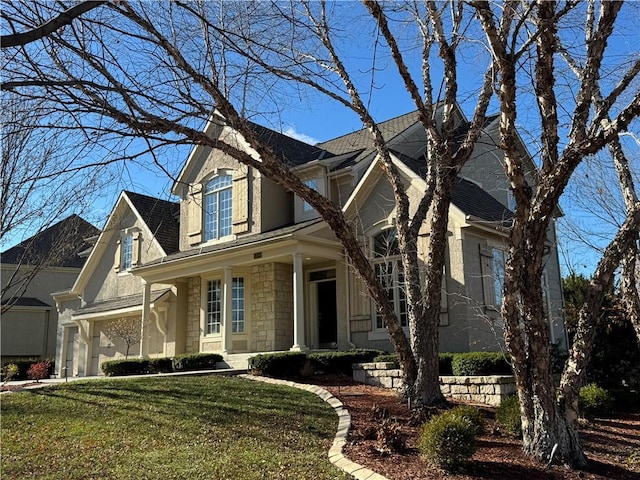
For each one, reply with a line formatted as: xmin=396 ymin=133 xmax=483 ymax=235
xmin=0 ymin=376 xmax=347 ymax=480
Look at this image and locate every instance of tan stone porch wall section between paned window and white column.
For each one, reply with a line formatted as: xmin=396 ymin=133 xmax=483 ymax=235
xmin=249 ymin=263 xmax=293 ymax=352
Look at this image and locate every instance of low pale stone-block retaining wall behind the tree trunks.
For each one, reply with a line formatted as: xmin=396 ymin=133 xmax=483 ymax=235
xmin=353 ymin=363 xmax=516 ymax=406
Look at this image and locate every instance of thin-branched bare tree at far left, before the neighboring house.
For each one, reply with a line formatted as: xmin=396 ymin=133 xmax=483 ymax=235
xmin=0 ymin=93 xmax=107 ymax=313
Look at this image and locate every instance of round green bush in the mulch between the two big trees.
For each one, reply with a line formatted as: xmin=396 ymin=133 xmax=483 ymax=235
xmin=418 ymin=411 xmax=477 ymax=470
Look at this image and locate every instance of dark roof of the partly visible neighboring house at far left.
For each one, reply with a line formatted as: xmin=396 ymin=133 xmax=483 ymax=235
xmin=0 ymin=215 xmax=100 ymax=268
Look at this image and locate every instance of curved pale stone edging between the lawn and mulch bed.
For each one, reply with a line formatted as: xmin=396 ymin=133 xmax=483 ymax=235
xmin=238 ymin=374 xmax=388 ymax=480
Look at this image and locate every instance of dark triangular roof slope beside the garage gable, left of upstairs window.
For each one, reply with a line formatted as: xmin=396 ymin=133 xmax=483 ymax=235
xmin=124 ymin=191 xmax=180 ymax=255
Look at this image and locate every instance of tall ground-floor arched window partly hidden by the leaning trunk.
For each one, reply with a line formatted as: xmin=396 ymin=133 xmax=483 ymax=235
xmin=373 ymin=228 xmax=409 ymax=329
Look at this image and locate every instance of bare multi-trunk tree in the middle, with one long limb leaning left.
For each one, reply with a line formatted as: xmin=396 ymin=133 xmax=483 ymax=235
xmin=3 ymin=2 xmax=493 ymax=405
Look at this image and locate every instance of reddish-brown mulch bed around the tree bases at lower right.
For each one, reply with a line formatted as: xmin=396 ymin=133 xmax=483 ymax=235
xmin=313 ymin=376 xmax=640 ymax=480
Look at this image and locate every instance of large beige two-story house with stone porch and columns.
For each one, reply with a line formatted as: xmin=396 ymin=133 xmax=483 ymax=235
xmin=53 ymin=107 xmax=565 ymax=375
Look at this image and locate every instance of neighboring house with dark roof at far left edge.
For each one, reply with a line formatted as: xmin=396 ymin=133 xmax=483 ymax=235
xmin=0 ymin=215 xmax=99 ymax=358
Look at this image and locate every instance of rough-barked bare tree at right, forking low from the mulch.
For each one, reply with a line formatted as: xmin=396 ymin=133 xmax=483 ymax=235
xmin=473 ymin=1 xmax=640 ymax=467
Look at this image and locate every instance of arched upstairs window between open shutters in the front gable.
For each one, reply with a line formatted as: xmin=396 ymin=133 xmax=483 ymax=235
xmin=204 ymin=175 xmax=233 ymax=241
